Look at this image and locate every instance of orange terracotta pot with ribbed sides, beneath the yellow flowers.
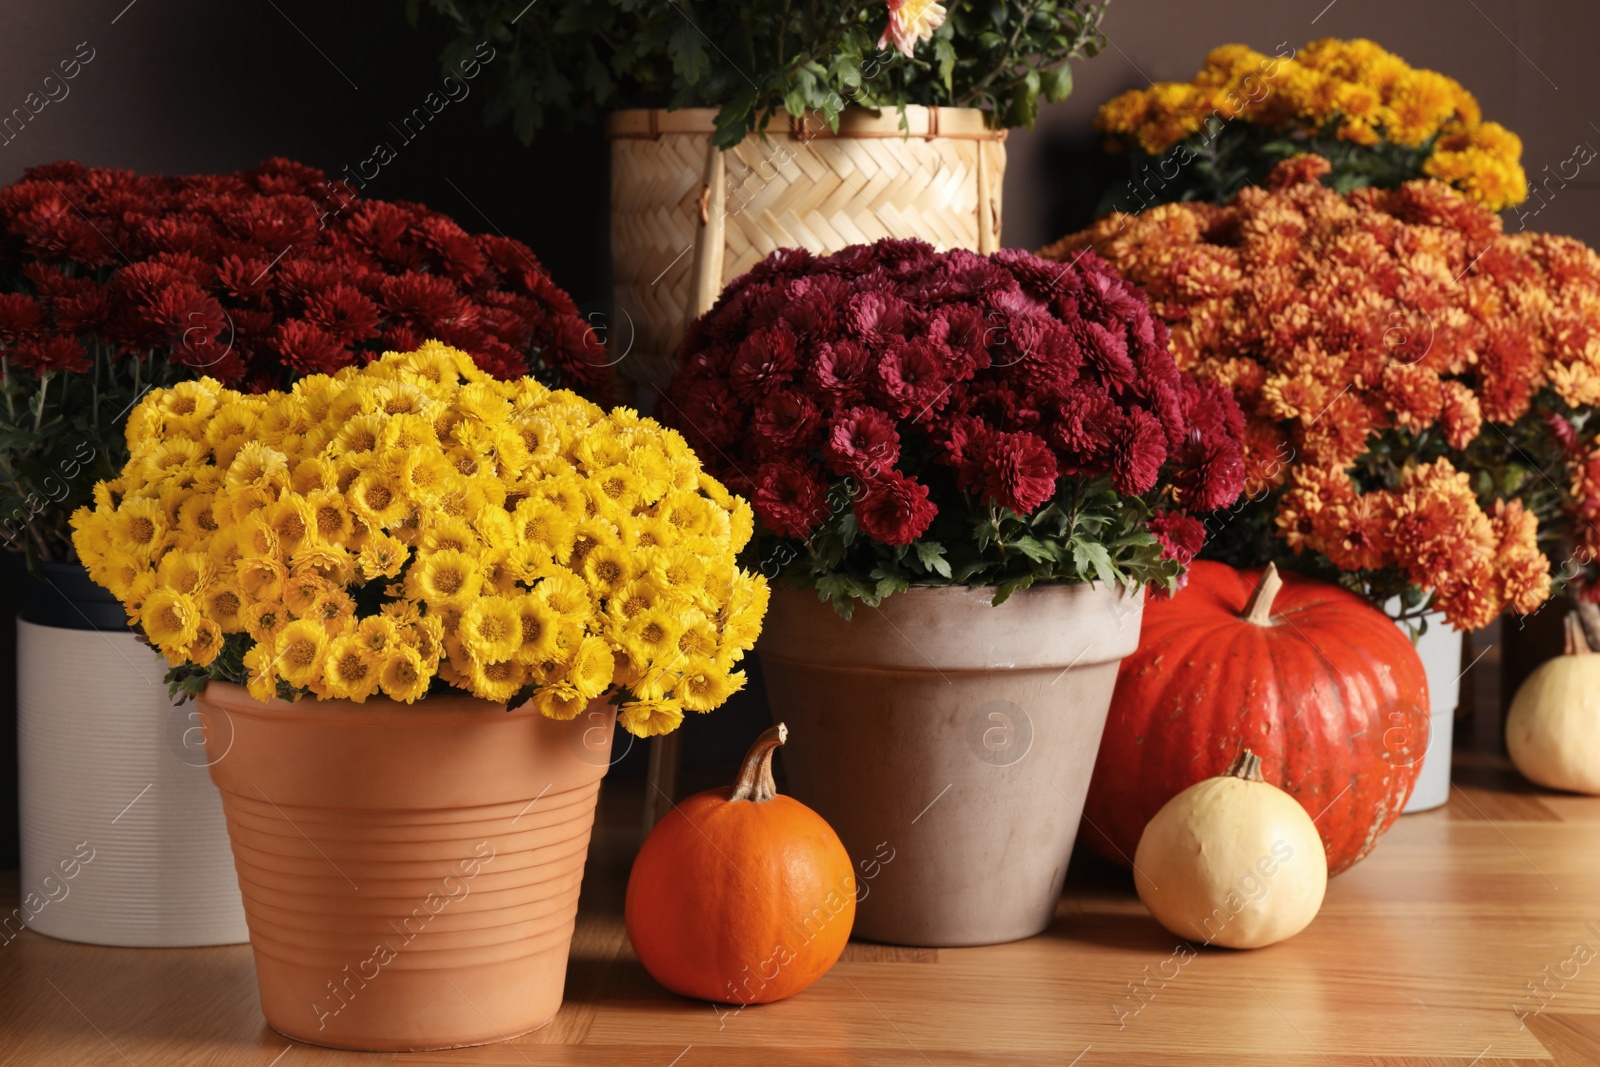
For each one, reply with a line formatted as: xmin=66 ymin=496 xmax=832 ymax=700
xmin=200 ymin=681 xmax=614 ymax=1051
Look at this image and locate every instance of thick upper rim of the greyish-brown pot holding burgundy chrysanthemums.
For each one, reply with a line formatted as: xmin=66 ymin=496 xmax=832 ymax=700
xmin=755 ymin=582 xmax=1144 ymax=672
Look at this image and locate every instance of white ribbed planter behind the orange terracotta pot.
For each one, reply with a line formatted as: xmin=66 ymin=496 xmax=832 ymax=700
xmin=16 ymin=619 xmax=250 ymax=947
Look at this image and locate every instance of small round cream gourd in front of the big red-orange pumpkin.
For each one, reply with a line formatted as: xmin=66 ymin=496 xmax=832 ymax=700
xmin=1133 ymin=750 xmax=1328 ymax=949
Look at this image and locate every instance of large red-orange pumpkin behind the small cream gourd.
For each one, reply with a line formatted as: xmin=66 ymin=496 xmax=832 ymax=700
xmin=1083 ymin=561 xmax=1429 ymax=873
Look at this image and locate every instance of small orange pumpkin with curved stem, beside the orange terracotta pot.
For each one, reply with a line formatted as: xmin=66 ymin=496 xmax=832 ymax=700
xmin=626 ymin=723 xmax=856 ymax=1005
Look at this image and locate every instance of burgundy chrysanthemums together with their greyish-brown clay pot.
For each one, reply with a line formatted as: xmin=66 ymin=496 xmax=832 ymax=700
xmin=664 ymin=240 xmax=1243 ymax=945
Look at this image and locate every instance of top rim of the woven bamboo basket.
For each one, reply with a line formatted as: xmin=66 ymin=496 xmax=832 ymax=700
xmin=605 ymin=104 xmax=1010 ymax=141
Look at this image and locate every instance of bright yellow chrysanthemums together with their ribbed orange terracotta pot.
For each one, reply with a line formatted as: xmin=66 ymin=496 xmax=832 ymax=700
xmin=72 ymin=342 xmax=766 ymax=1049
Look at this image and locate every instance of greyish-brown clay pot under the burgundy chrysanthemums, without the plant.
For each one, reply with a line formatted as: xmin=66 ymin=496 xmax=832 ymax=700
xmin=757 ymin=585 xmax=1144 ymax=945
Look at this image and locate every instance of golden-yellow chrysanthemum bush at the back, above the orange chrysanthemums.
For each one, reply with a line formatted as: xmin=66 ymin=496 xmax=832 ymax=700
xmin=1094 ymin=37 xmax=1528 ymax=211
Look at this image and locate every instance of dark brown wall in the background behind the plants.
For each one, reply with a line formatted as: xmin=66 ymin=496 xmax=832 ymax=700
xmin=0 ymin=0 xmax=1600 ymax=867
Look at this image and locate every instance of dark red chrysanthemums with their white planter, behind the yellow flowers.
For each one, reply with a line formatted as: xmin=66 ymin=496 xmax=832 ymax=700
xmin=0 ymin=158 xmax=606 ymax=945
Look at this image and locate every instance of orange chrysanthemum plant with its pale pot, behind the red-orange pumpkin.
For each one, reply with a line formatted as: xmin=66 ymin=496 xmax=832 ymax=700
xmin=1043 ymin=155 xmax=1600 ymax=811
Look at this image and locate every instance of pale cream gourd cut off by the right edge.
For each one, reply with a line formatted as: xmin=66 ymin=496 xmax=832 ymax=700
xmin=1506 ymin=614 xmax=1600 ymax=793
